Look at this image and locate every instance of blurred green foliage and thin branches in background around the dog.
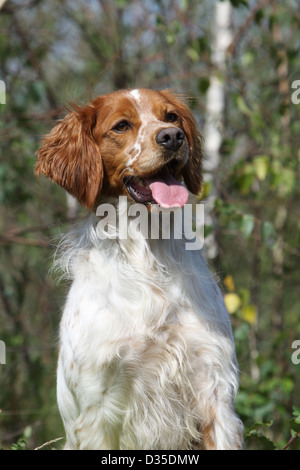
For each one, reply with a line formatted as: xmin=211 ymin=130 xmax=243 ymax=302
xmin=0 ymin=0 xmax=300 ymax=449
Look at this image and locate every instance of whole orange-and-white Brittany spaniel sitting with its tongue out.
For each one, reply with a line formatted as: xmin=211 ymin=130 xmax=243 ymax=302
xmin=35 ymin=89 xmax=243 ymax=450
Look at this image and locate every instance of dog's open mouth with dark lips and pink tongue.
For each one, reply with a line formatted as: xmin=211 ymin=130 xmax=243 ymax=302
xmin=124 ymin=167 xmax=189 ymax=208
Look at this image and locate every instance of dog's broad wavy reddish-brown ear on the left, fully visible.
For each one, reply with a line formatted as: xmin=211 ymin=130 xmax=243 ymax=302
xmin=35 ymin=105 xmax=103 ymax=210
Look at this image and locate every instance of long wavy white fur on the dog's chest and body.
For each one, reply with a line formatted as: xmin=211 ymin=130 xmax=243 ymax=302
xmin=57 ymin=200 xmax=242 ymax=450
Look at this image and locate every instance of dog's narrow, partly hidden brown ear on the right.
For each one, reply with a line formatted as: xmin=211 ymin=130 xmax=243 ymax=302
xmin=160 ymin=90 xmax=203 ymax=194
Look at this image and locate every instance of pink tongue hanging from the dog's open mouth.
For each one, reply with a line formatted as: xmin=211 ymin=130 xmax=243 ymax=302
xmin=146 ymin=173 xmax=189 ymax=208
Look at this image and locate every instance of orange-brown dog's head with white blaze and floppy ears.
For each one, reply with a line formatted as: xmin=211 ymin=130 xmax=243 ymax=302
xmin=35 ymin=89 xmax=202 ymax=210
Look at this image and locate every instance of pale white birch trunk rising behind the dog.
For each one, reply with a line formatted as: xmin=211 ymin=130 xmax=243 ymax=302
xmin=204 ymin=1 xmax=233 ymax=258
